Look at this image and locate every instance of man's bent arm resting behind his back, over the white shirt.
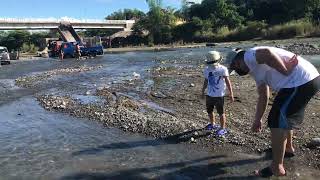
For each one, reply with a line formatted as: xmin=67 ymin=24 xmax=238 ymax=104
xmin=256 ymin=49 xmax=298 ymax=76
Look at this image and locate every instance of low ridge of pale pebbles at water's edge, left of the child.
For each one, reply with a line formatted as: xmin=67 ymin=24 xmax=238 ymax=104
xmin=38 ymin=90 xmax=204 ymax=137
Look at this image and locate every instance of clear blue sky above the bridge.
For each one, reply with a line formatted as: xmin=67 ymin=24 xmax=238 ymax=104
xmin=0 ymin=0 xmax=181 ymax=19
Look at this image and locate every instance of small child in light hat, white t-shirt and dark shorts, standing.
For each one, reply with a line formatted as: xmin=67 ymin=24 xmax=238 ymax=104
xmin=202 ymin=51 xmax=234 ymax=136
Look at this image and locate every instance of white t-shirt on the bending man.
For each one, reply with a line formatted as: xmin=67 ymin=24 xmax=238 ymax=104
xmin=244 ymin=46 xmax=319 ymax=91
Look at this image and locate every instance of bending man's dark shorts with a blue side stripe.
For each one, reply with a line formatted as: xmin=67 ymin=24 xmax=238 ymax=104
xmin=268 ymin=76 xmax=320 ymax=130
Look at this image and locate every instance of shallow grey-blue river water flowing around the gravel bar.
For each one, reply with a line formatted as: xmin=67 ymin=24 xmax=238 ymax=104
xmin=0 ymin=48 xmax=318 ymax=179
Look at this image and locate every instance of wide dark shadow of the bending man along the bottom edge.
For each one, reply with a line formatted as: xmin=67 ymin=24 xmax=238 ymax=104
xmin=60 ymin=156 xmax=261 ymax=180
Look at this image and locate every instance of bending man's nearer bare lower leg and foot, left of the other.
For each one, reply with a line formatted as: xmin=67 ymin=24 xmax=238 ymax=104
xmin=271 ymin=128 xmax=288 ymax=176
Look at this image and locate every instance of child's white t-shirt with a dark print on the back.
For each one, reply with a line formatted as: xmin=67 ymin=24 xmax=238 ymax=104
xmin=203 ymin=64 xmax=229 ymax=97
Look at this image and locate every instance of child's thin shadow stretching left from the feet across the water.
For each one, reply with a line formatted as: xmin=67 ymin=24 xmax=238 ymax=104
xmin=72 ymin=129 xmax=211 ymax=156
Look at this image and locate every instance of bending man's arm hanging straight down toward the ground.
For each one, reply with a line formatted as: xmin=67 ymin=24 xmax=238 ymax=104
xmin=252 ymin=84 xmax=269 ymax=132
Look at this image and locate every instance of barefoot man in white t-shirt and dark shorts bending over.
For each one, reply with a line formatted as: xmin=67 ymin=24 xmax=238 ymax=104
xmin=228 ymin=47 xmax=320 ymax=177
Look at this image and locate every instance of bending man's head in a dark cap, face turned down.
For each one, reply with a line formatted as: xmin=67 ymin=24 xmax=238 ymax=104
xmin=227 ymin=49 xmax=250 ymax=76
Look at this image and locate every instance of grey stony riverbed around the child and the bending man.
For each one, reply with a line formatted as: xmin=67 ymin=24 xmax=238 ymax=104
xmin=12 ymin=40 xmax=320 ymax=177
